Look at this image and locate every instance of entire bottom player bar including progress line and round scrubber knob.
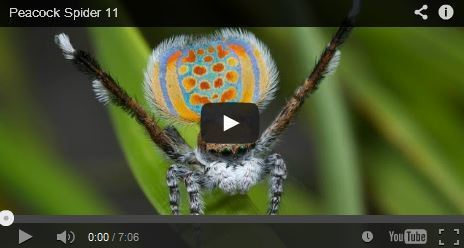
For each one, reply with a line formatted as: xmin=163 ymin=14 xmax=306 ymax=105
xmin=0 ymin=211 xmax=464 ymax=247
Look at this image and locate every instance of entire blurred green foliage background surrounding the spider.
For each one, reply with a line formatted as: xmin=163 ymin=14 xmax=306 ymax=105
xmin=0 ymin=28 xmax=464 ymax=215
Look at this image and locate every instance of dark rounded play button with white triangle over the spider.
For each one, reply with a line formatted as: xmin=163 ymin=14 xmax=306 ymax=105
xmin=200 ymin=103 xmax=259 ymax=144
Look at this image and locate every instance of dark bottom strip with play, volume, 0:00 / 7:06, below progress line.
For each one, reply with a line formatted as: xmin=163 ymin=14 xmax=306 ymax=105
xmin=0 ymin=220 xmax=464 ymax=248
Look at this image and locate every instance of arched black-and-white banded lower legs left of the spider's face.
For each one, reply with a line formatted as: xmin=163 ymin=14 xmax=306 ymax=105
xmin=166 ymin=164 xmax=203 ymax=215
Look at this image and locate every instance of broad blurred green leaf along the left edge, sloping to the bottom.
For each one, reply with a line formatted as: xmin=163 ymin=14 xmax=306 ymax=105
xmin=0 ymin=28 xmax=113 ymax=214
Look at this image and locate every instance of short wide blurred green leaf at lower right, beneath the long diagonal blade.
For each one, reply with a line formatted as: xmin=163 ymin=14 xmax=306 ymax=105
xmin=366 ymin=146 xmax=457 ymax=214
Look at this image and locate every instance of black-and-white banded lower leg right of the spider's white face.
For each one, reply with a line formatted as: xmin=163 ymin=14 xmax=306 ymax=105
xmin=265 ymin=153 xmax=287 ymax=215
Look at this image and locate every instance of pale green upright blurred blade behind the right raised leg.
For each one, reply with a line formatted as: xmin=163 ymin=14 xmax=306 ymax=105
xmin=272 ymin=28 xmax=364 ymax=214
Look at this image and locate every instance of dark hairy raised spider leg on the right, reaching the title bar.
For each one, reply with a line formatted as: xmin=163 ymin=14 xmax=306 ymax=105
xmin=255 ymin=18 xmax=353 ymax=154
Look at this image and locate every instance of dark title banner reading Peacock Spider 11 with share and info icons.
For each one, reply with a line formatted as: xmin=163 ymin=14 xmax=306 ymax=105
xmin=0 ymin=0 xmax=464 ymax=27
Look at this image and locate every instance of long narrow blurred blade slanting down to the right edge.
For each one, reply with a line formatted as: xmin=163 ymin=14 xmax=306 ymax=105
xmin=341 ymin=30 xmax=464 ymax=213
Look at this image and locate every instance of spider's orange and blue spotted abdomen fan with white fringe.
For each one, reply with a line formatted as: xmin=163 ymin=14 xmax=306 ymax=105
xmin=145 ymin=29 xmax=277 ymax=122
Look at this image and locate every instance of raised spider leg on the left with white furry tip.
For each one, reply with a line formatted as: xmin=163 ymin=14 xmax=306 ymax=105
xmin=55 ymin=33 xmax=196 ymax=165
